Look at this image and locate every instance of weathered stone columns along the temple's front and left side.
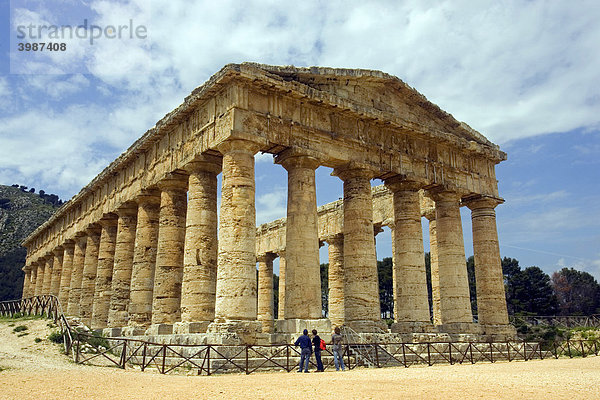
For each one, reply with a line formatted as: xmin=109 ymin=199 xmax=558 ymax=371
xmin=25 ymin=139 xmax=508 ymax=332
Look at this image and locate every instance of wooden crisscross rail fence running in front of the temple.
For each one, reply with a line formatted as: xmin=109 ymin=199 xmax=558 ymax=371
xmin=0 ymin=296 xmax=600 ymax=375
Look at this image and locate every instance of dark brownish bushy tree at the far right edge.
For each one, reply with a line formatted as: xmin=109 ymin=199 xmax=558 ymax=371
xmin=552 ymin=268 xmax=600 ymax=315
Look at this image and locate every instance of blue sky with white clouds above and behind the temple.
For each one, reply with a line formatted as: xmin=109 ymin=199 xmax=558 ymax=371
xmin=0 ymin=0 xmax=600 ymax=279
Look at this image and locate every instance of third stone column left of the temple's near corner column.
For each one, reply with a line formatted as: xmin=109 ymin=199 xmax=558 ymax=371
xmin=128 ymin=190 xmax=160 ymax=334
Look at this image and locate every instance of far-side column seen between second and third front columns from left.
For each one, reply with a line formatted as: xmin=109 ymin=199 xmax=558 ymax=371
xmin=325 ymin=234 xmax=345 ymax=327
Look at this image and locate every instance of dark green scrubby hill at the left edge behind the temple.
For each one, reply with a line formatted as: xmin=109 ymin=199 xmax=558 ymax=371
xmin=0 ymin=185 xmax=59 ymax=301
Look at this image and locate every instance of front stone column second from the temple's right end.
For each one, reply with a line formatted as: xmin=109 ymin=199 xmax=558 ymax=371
xmin=432 ymin=191 xmax=478 ymax=333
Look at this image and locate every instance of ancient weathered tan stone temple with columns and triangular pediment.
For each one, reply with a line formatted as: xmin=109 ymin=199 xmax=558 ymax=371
xmin=23 ymin=63 xmax=513 ymax=342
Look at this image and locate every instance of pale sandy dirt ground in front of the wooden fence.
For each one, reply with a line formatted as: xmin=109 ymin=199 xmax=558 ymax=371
xmin=0 ymin=320 xmax=600 ymax=400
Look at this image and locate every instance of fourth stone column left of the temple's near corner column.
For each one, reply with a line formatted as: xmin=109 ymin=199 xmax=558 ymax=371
xmin=108 ymin=203 xmax=138 ymax=328
